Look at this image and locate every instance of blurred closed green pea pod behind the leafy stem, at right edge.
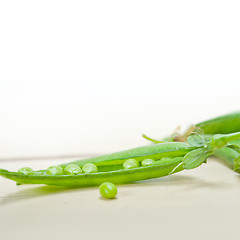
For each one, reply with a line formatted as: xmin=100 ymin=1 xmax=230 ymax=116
xmin=196 ymin=112 xmax=240 ymax=134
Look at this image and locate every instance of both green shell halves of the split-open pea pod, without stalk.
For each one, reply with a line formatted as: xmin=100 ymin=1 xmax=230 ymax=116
xmin=0 ymin=142 xmax=195 ymax=187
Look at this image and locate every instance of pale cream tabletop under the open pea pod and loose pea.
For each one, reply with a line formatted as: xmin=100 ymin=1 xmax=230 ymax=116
xmin=0 ymin=159 xmax=240 ymax=240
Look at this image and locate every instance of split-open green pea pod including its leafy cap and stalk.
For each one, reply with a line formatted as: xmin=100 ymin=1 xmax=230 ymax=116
xmin=0 ymin=132 xmax=240 ymax=187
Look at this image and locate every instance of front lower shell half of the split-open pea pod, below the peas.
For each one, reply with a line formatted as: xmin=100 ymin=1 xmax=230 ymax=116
xmin=0 ymin=157 xmax=184 ymax=187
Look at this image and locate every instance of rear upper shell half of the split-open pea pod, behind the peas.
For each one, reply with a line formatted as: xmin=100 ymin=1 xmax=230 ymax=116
xmin=60 ymin=142 xmax=194 ymax=171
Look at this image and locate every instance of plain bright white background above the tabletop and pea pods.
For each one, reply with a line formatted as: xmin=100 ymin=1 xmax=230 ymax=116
xmin=0 ymin=0 xmax=240 ymax=159
